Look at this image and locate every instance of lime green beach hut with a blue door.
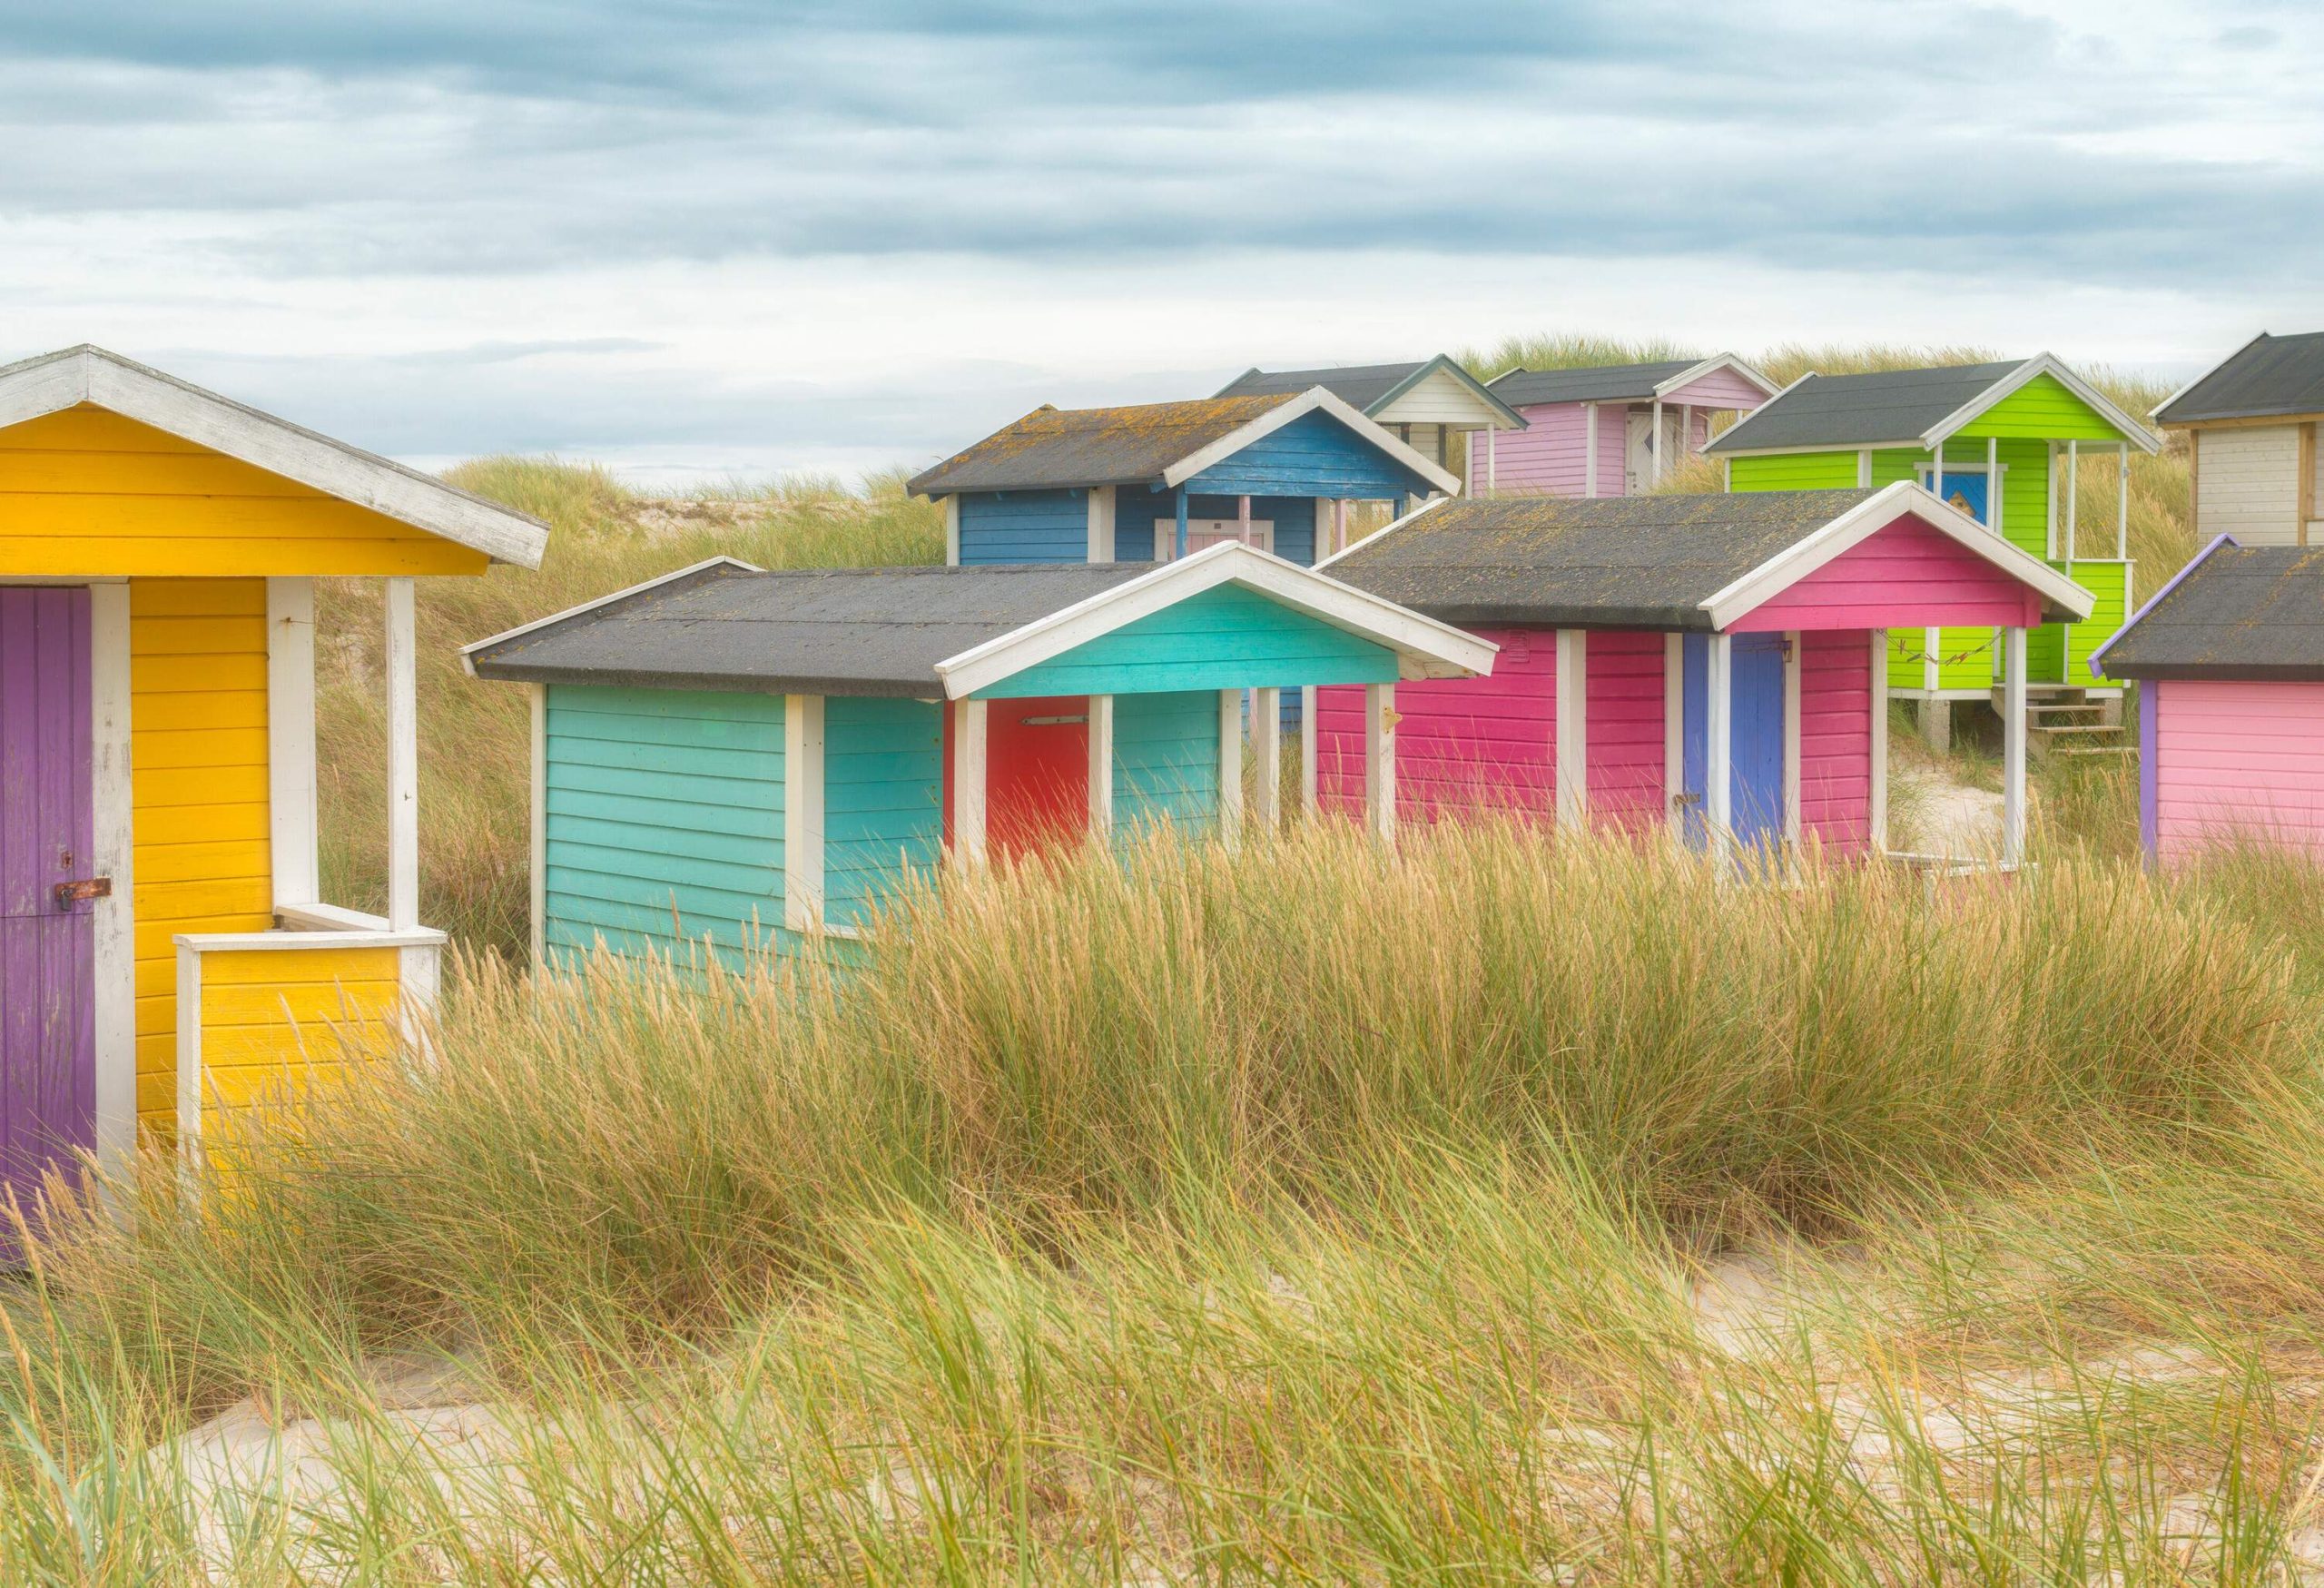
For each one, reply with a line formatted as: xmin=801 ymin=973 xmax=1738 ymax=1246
xmin=1706 ymin=353 xmax=2162 ymax=744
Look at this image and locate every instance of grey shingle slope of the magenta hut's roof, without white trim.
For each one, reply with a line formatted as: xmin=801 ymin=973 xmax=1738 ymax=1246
xmin=1327 ymin=490 xmax=1877 ymax=630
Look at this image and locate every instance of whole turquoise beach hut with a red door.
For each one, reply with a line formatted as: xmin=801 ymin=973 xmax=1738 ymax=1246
xmin=465 ymin=544 xmax=1492 ymax=962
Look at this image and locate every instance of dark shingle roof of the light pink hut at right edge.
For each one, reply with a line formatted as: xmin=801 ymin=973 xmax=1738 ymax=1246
xmin=2105 ymin=547 xmax=2324 ymax=679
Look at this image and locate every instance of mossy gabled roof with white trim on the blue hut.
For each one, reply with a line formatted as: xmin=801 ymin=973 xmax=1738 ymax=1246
xmin=906 ymin=386 xmax=1460 ymax=498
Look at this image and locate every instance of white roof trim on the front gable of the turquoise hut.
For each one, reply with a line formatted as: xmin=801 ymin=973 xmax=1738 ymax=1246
xmin=937 ymin=539 xmax=1499 ymax=700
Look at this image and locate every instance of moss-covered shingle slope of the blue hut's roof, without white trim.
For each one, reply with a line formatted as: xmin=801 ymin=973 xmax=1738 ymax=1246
xmin=906 ymin=390 xmax=1295 ymax=495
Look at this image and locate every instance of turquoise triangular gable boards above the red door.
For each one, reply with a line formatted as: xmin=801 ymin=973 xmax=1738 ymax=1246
xmin=976 ymin=586 xmax=1397 ymax=700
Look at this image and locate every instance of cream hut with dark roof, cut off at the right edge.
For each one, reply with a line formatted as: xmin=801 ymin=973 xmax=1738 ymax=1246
xmin=2154 ymin=330 xmax=2324 ymax=547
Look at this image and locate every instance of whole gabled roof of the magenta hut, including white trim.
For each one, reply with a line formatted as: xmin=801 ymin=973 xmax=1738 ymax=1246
xmin=1324 ymin=481 xmax=2092 ymax=630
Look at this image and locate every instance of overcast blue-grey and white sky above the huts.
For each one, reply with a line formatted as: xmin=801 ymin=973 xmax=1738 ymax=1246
xmin=0 ymin=0 xmax=2324 ymax=481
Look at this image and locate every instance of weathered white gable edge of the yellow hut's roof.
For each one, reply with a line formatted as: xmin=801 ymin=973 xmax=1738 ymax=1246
xmin=0 ymin=344 xmax=548 ymax=567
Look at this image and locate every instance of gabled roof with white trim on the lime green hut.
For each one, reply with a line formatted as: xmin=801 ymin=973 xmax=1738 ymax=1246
xmin=1703 ymin=353 xmax=2162 ymax=456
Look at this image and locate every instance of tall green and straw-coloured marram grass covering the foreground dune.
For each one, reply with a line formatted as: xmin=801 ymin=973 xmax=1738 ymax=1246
xmin=0 ymin=828 xmax=2324 ymax=1583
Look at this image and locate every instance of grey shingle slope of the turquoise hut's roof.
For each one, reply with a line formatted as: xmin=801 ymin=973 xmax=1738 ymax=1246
xmin=469 ymin=563 xmax=1153 ymax=700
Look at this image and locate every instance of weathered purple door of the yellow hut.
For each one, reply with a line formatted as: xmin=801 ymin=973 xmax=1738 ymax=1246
xmin=0 ymin=588 xmax=98 ymax=1260
